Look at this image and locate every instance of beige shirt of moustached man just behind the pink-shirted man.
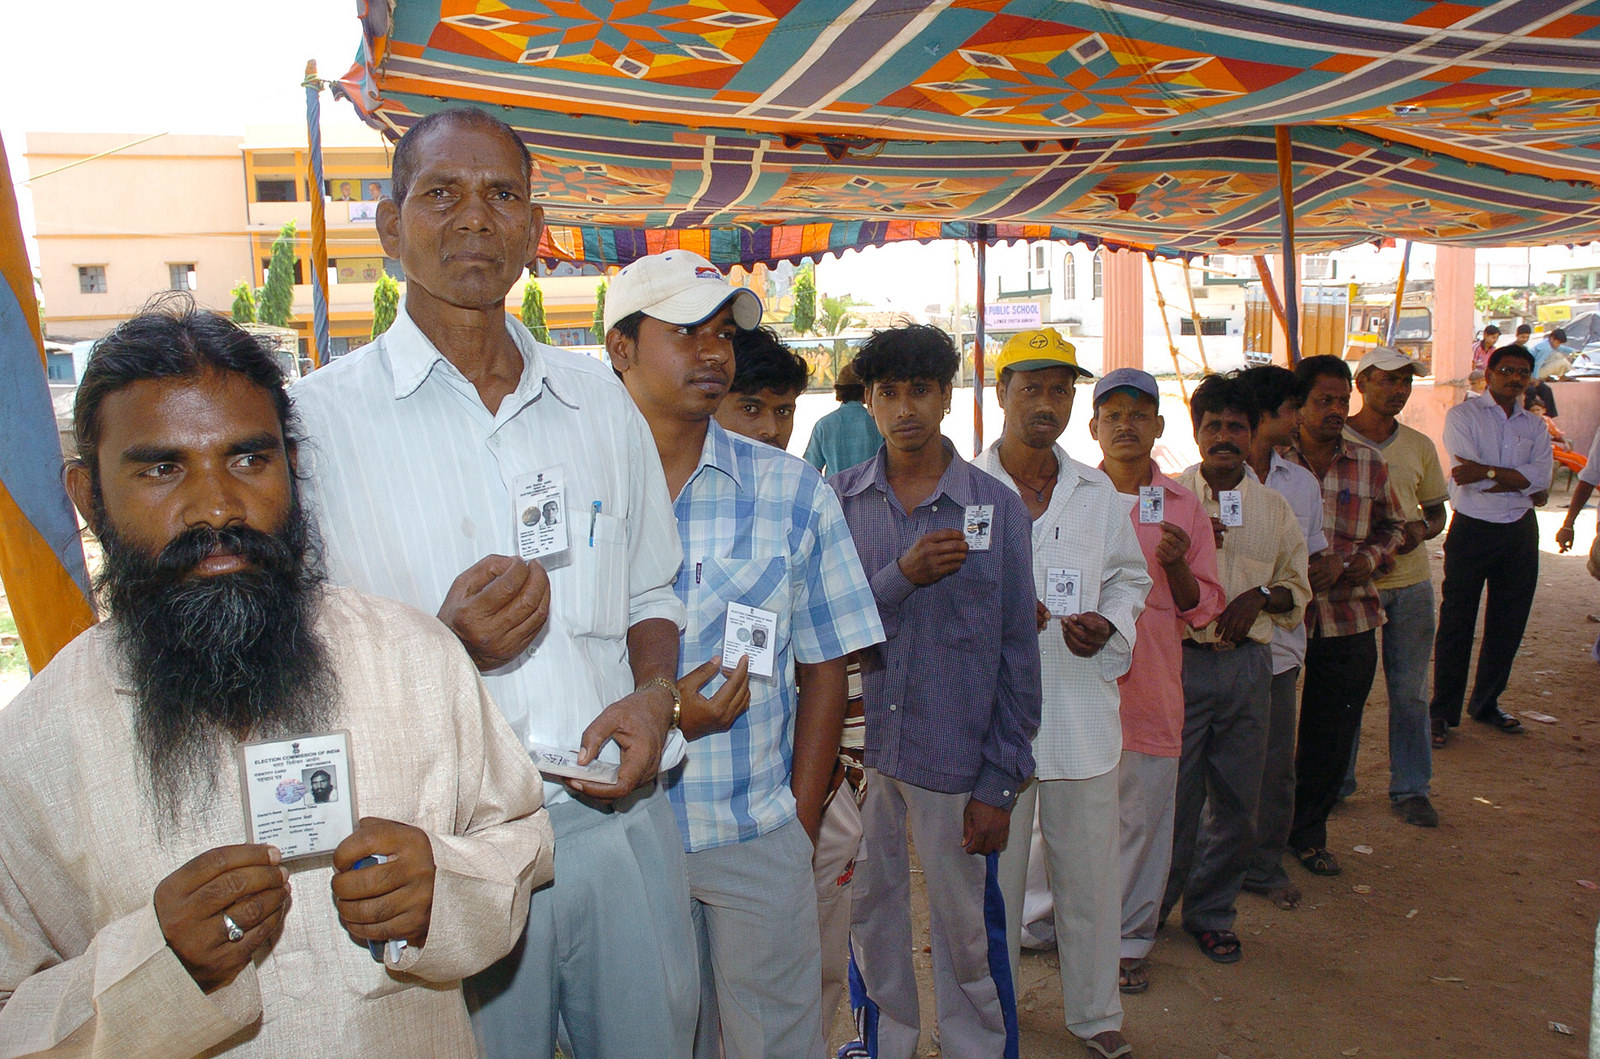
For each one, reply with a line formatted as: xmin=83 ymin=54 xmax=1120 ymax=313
xmin=1178 ymin=464 xmax=1310 ymax=643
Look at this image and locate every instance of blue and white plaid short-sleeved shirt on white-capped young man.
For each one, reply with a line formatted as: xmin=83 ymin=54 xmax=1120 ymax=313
xmin=667 ymin=421 xmax=883 ymax=853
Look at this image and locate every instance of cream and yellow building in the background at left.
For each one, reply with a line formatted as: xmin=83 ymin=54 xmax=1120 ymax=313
xmin=27 ymin=125 xmax=600 ymax=357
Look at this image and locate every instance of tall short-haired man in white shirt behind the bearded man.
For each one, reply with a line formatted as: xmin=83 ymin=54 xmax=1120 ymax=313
xmin=294 ymin=107 xmax=699 ymax=1059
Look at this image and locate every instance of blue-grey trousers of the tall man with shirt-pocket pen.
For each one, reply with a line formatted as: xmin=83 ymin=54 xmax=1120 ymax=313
xmin=466 ymin=784 xmax=699 ymax=1059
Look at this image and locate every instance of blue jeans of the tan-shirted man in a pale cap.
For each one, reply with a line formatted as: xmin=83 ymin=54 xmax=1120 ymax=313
xmin=1339 ymin=581 xmax=1434 ymax=798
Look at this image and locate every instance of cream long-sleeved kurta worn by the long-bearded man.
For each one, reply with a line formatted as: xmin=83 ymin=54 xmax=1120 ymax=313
xmin=0 ymin=589 xmax=554 ymax=1059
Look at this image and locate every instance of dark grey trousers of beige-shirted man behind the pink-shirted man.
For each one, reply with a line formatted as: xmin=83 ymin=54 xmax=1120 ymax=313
xmin=1162 ymin=643 xmax=1272 ymax=933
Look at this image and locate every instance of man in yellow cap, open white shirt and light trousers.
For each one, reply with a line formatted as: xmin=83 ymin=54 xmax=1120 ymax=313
xmin=978 ymin=328 xmax=1150 ymax=1056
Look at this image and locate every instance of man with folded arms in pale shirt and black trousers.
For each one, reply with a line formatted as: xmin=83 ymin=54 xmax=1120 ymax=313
xmin=1429 ymin=346 xmax=1552 ymax=747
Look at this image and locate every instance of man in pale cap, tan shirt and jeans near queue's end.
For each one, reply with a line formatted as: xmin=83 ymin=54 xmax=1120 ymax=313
xmin=1341 ymin=346 xmax=1450 ymax=827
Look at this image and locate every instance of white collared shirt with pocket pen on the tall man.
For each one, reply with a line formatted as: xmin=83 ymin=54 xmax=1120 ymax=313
xmin=293 ymin=307 xmax=683 ymax=803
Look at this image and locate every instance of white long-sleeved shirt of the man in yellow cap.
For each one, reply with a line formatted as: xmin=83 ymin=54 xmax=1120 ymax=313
xmin=974 ymin=442 xmax=1152 ymax=779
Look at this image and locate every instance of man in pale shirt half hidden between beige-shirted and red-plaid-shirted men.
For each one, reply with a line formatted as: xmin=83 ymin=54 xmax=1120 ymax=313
xmin=1238 ymin=365 xmax=1331 ymax=910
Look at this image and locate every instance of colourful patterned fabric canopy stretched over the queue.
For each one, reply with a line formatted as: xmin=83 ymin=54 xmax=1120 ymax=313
xmin=338 ymin=0 xmax=1600 ymax=266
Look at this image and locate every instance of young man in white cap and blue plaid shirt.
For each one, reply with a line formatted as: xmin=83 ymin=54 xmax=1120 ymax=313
xmin=605 ymin=250 xmax=883 ymax=1059
